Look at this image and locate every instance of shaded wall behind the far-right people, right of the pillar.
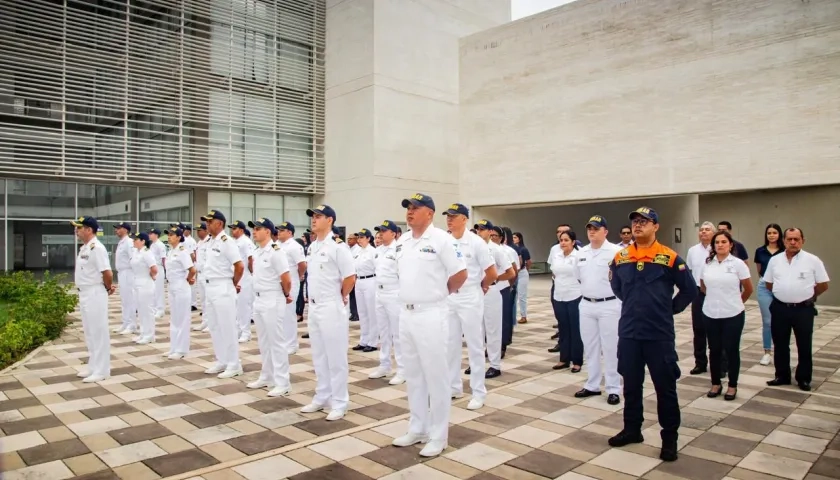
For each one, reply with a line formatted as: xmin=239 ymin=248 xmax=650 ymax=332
xmin=700 ymin=185 xmax=840 ymax=305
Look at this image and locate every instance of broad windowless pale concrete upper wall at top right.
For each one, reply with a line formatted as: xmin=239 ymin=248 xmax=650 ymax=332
xmin=460 ymin=0 xmax=840 ymax=205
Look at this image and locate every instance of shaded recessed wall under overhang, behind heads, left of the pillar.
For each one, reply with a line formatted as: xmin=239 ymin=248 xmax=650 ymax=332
xmin=473 ymin=195 xmax=698 ymax=262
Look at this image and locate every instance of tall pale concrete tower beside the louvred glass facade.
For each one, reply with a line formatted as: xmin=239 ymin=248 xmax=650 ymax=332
xmin=314 ymin=0 xmax=510 ymax=231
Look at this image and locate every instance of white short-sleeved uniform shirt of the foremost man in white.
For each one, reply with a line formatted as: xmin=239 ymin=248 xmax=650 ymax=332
xmin=397 ymin=225 xmax=467 ymax=304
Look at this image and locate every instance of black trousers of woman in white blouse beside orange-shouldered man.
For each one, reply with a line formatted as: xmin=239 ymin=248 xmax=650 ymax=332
xmin=706 ymin=312 xmax=746 ymax=388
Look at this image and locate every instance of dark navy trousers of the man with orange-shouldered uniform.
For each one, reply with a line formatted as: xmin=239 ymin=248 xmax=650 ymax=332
xmin=618 ymin=338 xmax=681 ymax=442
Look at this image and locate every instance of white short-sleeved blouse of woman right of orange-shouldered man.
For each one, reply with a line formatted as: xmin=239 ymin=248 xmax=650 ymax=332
xmin=700 ymin=254 xmax=750 ymax=318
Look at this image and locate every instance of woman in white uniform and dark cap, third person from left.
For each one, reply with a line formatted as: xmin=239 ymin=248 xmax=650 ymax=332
xmin=130 ymin=233 xmax=158 ymax=345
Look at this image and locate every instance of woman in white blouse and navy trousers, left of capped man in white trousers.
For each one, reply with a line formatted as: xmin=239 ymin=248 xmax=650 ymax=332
xmin=548 ymin=232 xmax=583 ymax=373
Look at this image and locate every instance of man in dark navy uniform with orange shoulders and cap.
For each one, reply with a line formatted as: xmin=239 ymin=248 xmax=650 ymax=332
xmin=609 ymin=207 xmax=697 ymax=462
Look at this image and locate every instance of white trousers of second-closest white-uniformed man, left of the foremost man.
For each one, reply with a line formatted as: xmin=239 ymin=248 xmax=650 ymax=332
xmin=309 ymin=298 xmax=350 ymax=411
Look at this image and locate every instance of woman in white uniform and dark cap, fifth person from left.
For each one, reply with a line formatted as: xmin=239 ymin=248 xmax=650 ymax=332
xmin=164 ymin=228 xmax=195 ymax=360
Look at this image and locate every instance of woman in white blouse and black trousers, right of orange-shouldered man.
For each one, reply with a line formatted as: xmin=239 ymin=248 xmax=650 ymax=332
xmin=700 ymin=232 xmax=753 ymax=400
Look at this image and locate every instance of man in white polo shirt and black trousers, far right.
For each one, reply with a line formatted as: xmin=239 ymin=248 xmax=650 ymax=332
xmin=764 ymin=228 xmax=828 ymax=392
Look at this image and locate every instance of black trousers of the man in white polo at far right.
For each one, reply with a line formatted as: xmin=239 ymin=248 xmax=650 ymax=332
xmin=770 ymin=298 xmax=816 ymax=383
